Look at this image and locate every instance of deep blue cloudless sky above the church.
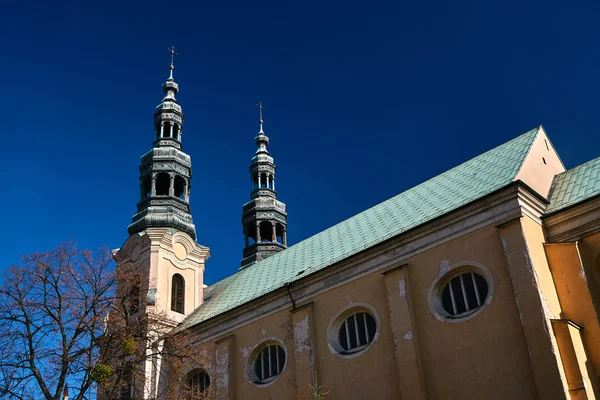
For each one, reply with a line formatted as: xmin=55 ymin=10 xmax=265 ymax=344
xmin=0 ymin=0 xmax=600 ymax=283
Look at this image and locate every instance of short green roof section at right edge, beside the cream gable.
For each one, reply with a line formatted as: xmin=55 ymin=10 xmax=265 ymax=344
xmin=546 ymin=157 xmax=600 ymax=214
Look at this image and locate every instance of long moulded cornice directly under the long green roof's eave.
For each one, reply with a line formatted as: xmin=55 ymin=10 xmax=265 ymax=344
xmin=184 ymin=182 xmax=545 ymax=340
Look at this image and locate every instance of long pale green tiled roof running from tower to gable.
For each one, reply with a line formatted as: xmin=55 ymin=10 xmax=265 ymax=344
xmin=182 ymin=128 xmax=539 ymax=328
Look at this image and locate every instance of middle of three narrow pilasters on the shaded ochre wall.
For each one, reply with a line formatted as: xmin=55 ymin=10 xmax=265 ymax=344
xmin=292 ymin=303 xmax=317 ymax=400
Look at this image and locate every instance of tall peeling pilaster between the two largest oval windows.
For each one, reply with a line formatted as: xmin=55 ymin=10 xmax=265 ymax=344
xmin=383 ymin=264 xmax=427 ymax=399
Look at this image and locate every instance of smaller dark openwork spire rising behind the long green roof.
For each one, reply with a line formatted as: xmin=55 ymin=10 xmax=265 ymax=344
xmin=240 ymin=103 xmax=287 ymax=269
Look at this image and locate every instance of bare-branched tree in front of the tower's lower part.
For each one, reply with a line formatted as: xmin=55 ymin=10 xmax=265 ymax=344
xmin=0 ymin=242 xmax=206 ymax=400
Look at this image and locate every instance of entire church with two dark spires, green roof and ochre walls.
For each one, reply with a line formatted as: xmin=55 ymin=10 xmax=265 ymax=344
xmin=114 ymin=57 xmax=600 ymax=400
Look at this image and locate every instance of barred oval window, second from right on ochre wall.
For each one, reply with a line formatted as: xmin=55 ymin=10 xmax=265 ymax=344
xmin=338 ymin=312 xmax=377 ymax=354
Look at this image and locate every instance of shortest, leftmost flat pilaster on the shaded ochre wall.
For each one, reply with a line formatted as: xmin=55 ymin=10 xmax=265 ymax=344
xmin=213 ymin=335 xmax=235 ymax=400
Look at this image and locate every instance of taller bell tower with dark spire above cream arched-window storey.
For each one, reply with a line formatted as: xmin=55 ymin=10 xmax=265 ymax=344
xmin=113 ymin=48 xmax=210 ymax=326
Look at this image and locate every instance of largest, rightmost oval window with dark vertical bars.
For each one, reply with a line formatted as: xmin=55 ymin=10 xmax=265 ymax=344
xmin=442 ymin=272 xmax=488 ymax=318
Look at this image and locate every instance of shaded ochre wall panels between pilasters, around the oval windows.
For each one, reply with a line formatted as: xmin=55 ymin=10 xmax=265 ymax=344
xmin=189 ymin=223 xmax=538 ymax=400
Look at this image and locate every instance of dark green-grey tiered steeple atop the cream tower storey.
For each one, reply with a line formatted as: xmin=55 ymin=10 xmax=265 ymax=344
xmin=128 ymin=48 xmax=196 ymax=239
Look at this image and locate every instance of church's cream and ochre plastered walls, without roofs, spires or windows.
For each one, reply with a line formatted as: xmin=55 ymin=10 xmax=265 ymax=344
xmin=117 ymin=127 xmax=600 ymax=400
